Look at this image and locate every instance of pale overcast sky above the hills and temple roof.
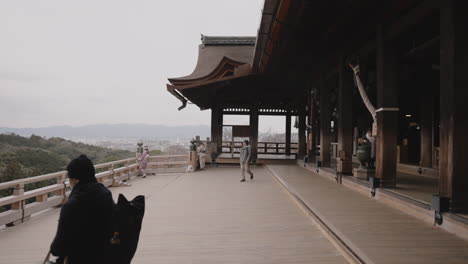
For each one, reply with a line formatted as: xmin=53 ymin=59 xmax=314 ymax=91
xmin=0 ymin=0 xmax=288 ymax=130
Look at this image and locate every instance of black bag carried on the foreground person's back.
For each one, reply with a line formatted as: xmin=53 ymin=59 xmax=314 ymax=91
xmin=104 ymin=194 xmax=145 ymax=264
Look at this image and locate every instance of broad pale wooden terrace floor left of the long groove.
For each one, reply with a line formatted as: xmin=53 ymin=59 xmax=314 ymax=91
xmin=0 ymin=167 xmax=347 ymax=264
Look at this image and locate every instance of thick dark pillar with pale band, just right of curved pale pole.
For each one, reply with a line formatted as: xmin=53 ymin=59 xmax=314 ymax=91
xmin=376 ymin=26 xmax=399 ymax=188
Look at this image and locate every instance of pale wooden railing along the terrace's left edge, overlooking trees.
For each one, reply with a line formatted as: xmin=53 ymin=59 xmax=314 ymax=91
xmin=0 ymin=155 xmax=188 ymax=226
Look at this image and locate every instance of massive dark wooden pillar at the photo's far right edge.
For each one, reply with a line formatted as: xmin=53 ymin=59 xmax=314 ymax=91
xmin=439 ymin=0 xmax=468 ymax=212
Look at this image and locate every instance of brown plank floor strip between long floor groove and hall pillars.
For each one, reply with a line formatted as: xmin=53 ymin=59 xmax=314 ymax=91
xmin=267 ymin=165 xmax=468 ymax=264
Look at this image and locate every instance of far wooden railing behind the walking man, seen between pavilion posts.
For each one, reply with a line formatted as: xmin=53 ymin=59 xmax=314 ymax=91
xmin=222 ymin=141 xmax=298 ymax=155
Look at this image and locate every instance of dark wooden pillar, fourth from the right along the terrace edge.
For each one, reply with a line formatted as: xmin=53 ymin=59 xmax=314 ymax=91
xmin=319 ymin=79 xmax=331 ymax=167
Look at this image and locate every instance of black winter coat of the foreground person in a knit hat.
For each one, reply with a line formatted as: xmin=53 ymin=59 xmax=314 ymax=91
xmin=50 ymin=182 xmax=114 ymax=264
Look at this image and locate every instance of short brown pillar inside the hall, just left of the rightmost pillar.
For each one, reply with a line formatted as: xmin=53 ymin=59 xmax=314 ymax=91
xmin=420 ymin=96 xmax=434 ymax=168
